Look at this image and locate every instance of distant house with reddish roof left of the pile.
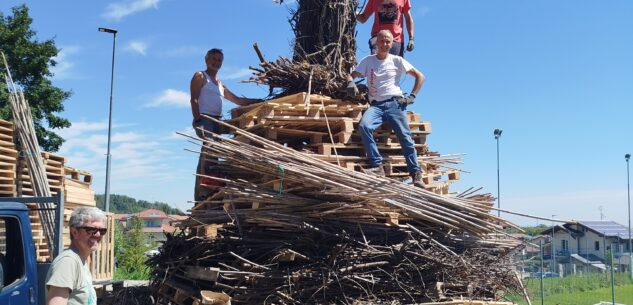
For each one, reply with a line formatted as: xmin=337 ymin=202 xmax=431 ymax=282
xmin=115 ymin=209 xmax=187 ymax=242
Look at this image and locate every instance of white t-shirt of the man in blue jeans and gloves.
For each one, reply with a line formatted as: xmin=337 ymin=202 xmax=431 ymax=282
xmin=355 ymin=54 xmax=413 ymax=101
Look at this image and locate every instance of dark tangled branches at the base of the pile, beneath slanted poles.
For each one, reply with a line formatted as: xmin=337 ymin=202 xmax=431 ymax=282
xmin=149 ymin=221 xmax=520 ymax=304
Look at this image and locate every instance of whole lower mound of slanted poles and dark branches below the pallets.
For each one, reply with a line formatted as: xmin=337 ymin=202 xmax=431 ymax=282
xmin=149 ymin=118 xmax=521 ymax=304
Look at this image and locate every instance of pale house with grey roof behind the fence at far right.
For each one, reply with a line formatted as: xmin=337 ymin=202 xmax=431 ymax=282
xmin=541 ymin=221 xmax=631 ymax=274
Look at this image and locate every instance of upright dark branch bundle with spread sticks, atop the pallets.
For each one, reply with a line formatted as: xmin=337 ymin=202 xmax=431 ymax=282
xmin=247 ymin=0 xmax=358 ymax=98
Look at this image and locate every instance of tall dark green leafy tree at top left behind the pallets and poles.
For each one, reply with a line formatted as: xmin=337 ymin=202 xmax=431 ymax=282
xmin=0 ymin=5 xmax=71 ymax=151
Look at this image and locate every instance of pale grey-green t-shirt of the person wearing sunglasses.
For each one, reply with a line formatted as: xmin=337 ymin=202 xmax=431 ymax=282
xmin=46 ymin=249 xmax=97 ymax=305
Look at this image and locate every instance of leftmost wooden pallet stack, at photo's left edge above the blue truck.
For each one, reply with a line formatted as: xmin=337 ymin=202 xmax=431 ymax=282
xmin=0 ymin=120 xmax=18 ymax=197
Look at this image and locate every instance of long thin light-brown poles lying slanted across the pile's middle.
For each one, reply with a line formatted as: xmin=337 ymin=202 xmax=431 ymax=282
xmin=179 ymin=116 xmax=520 ymax=236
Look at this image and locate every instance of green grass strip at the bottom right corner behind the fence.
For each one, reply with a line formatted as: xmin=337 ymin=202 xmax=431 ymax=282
xmin=508 ymin=273 xmax=633 ymax=305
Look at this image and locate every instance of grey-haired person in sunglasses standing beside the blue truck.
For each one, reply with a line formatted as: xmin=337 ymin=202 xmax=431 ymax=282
xmin=46 ymin=207 xmax=107 ymax=305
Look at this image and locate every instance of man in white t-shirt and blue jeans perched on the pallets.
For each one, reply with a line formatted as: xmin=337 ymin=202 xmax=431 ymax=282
xmin=347 ymin=30 xmax=424 ymax=188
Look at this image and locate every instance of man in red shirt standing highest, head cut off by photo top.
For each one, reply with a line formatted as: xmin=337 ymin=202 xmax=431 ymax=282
xmin=356 ymin=0 xmax=414 ymax=56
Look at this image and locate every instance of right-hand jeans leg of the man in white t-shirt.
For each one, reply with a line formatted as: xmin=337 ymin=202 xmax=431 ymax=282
xmin=385 ymin=101 xmax=420 ymax=174
